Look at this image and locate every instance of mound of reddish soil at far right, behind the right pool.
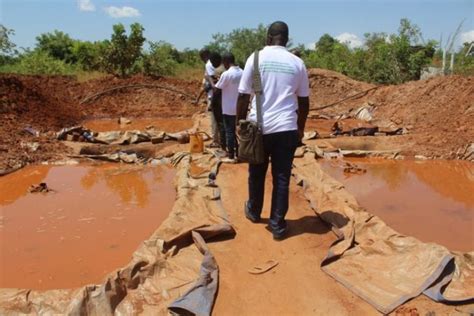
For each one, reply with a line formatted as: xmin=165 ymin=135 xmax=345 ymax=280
xmin=370 ymin=76 xmax=474 ymax=158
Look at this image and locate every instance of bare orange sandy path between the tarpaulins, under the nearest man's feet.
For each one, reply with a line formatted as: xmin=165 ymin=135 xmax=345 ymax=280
xmin=209 ymin=164 xmax=466 ymax=315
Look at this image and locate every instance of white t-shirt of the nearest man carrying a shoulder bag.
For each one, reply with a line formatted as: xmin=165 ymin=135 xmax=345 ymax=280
xmin=239 ymin=46 xmax=309 ymax=134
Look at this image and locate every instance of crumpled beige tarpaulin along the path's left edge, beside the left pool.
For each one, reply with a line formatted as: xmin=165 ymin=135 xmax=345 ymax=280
xmin=0 ymin=153 xmax=233 ymax=315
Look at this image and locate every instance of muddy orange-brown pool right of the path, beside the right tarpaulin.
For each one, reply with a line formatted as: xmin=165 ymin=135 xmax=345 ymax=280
xmin=321 ymin=159 xmax=474 ymax=252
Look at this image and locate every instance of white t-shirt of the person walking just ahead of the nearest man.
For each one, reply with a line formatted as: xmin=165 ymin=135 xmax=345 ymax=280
xmin=216 ymin=66 xmax=242 ymax=115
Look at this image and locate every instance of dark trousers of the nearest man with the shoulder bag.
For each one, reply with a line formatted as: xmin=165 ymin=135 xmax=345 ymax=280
xmin=247 ymin=131 xmax=299 ymax=235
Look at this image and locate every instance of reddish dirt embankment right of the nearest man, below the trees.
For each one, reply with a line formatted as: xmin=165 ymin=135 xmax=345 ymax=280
xmin=309 ymin=69 xmax=474 ymax=158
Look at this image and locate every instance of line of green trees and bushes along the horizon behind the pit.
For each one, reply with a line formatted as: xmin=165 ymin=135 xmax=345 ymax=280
xmin=0 ymin=19 xmax=474 ymax=84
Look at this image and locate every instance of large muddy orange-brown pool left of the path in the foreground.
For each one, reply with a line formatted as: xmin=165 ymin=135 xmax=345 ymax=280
xmin=0 ymin=164 xmax=176 ymax=290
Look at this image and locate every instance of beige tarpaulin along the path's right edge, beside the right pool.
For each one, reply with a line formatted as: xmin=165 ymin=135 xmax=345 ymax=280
xmin=293 ymin=153 xmax=474 ymax=313
